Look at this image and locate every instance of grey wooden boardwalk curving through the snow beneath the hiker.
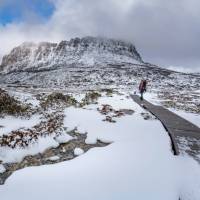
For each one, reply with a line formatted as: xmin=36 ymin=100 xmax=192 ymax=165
xmin=131 ymin=95 xmax=200 ymax=163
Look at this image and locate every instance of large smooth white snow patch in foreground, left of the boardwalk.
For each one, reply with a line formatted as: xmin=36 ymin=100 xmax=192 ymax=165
xmin=0 ymin=95 xmax=200 ymax=200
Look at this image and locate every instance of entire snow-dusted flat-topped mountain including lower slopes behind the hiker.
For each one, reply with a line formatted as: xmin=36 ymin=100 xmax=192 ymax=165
xmin=0 ymin=37 xmax=200 ymax=94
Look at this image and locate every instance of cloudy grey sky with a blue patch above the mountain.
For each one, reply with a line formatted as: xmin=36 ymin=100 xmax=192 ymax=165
xmin=0 ymin=0 xmax=200 ymax=72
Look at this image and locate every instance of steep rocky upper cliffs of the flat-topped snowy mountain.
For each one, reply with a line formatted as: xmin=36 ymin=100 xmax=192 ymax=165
xmin=1 ymin=37 xmax=143 ymax=73
